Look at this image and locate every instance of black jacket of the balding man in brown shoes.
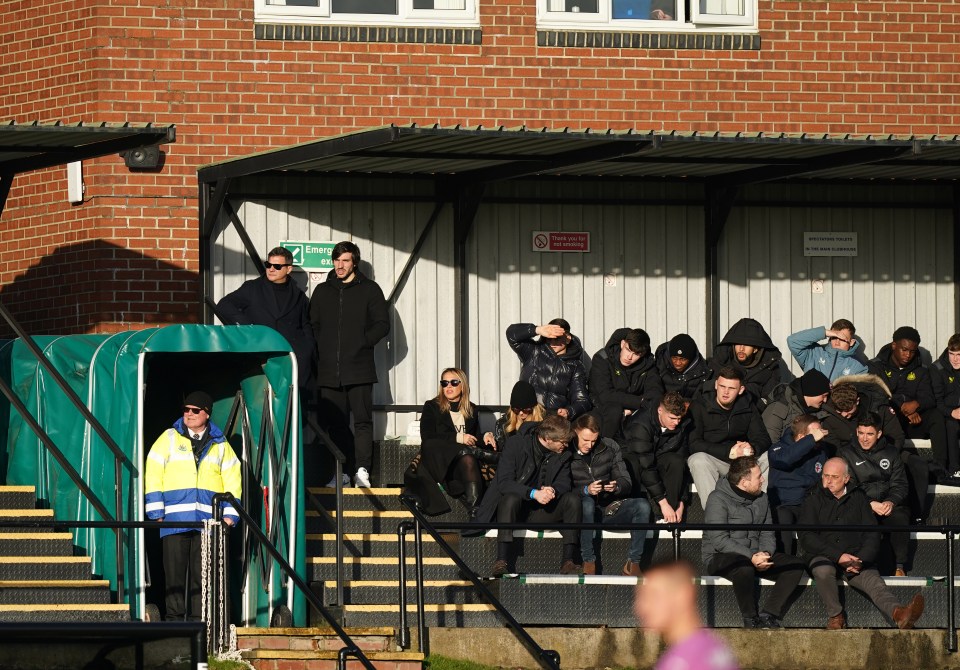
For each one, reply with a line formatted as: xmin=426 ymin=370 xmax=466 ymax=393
xmin=797 ymin=480 xmax=880 ymax=564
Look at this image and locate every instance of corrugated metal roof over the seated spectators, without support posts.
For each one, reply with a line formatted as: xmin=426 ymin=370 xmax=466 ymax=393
xmin=199 ymin=125 xmax=960 ymax=184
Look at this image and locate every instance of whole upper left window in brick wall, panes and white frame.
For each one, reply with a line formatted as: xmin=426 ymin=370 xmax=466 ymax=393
xmin=254 ymin=0 xmax=477 ymax=26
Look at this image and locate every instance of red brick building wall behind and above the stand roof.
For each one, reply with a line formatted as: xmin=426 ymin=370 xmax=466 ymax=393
xmin=0 ymin=0 xmax=960 ymax=332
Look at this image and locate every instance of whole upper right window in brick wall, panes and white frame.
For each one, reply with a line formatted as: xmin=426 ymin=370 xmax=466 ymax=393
xmin=537 ymin=0 xmax=757 ymax=31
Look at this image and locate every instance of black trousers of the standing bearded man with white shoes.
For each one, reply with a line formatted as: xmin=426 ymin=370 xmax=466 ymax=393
xmin=317 ymin=384 xmax=373 ymax=472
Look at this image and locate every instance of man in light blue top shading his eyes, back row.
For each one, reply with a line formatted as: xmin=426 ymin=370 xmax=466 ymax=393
xmin=787 ymin=319 xmax=867 ymax=382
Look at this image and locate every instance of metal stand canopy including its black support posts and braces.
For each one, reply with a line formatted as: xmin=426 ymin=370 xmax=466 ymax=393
xmin=197 ymin=125 xmax=960 ymax=364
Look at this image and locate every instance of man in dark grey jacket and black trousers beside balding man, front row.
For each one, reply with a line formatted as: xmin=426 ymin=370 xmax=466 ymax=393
xmin=703 ymin=456 xmax=806 ymax=628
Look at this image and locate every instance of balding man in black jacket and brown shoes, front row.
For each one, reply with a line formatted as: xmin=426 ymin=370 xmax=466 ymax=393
xmin=800 ymin=458 xmax=924 ymax=630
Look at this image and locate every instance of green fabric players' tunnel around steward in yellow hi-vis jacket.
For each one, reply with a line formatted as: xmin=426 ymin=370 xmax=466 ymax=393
xmin=0 ymin=325 xmax=306 ymax=625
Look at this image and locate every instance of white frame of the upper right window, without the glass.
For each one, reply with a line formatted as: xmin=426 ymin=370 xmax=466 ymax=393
xmin=536 ymin=0 xmax=759 ymax=33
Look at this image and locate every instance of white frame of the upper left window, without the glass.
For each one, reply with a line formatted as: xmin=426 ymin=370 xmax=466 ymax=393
xmin=253 ymin=0 xmax=480 ymax=28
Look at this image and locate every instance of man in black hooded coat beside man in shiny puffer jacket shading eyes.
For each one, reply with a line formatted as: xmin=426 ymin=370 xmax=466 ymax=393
xmin=590 ymin=328 xmax=663 ymax=437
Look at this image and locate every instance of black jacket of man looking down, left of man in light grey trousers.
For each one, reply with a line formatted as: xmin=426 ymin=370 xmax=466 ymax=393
xmin=623 ymin=405 xmax=693 ymax=502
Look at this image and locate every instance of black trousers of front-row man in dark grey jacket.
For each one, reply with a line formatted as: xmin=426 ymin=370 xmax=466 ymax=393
xmin=707 ymin=552 xmax=807 ymax=618
